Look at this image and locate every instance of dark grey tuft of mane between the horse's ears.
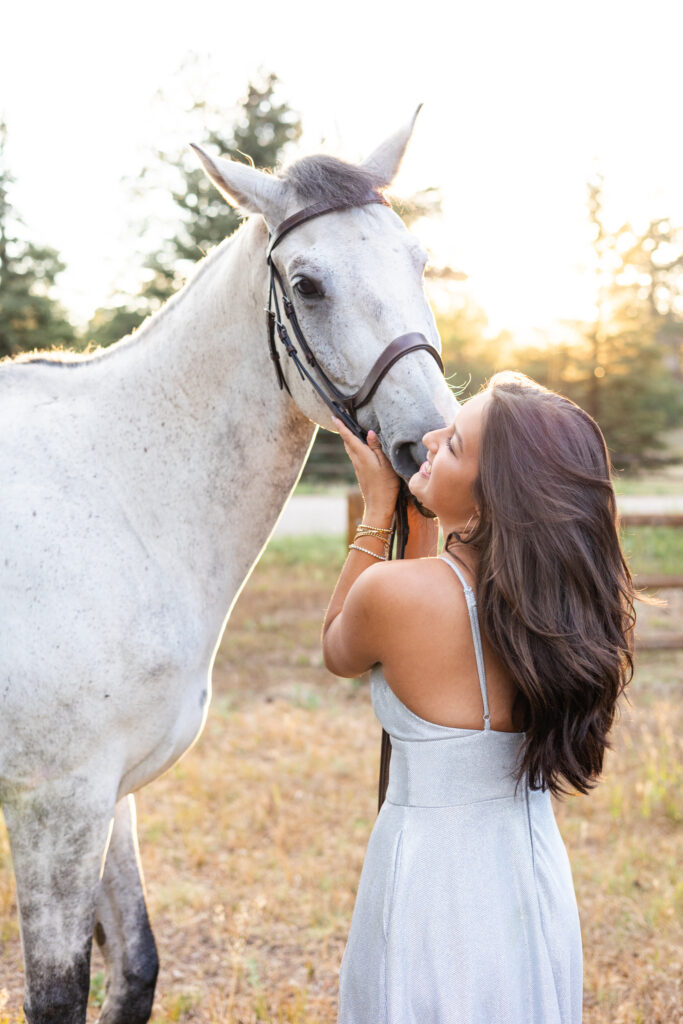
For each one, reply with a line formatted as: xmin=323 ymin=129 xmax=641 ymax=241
xmin=282 ymin=156 xmax=387 ymax=206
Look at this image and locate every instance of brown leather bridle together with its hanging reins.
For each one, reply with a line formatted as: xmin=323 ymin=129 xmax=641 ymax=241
xmin=265 ymin=193 xmax=443 ymax=810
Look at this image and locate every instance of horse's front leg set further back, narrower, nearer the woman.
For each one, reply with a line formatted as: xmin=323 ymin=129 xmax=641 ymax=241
xmin=95 ymin=796 xmax=159 ymax=1024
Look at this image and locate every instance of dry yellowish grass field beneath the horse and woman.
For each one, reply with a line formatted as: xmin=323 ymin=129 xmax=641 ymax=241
xmin=0 ymin=530 xmax=683 ymax=1024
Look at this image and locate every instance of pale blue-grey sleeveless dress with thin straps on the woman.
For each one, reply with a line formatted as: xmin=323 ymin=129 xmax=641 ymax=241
xmin=338 ymin=556 xmax=583 ymax=1024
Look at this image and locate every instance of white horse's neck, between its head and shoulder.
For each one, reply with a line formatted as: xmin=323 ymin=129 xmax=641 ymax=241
xmin=102 ymin=218 xmax=315 ymax=614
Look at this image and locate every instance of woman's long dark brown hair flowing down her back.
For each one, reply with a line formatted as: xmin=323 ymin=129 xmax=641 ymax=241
xmin=446 ymin=374 xmax=635 ymax=796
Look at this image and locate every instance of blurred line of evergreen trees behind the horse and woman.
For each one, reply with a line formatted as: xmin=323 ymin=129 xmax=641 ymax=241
xmin=0 ymin=74 xmax=683 ymax=480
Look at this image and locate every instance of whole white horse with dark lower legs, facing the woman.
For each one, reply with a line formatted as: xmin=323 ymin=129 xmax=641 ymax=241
xmin=0 ymin=108 xmax=456 ymax=1024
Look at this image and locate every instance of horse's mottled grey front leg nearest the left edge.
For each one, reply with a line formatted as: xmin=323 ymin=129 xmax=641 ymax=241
xmin=3 ymin=778 xmax=114 ymax=1024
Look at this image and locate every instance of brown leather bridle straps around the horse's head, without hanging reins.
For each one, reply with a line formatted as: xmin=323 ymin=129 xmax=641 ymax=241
xmin=266 ymin=193 xmax=443 ymax=440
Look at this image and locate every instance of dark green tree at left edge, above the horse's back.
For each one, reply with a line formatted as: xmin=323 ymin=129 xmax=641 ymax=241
xmin=0 ymin=122 xmax=76 ymax=357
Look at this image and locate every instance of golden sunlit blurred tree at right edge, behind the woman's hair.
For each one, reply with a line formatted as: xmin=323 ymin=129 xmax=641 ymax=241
xmin=518 ymin=176 xmax=683 ymax=468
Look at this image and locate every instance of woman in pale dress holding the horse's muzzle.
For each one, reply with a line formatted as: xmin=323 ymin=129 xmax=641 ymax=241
xmin=323 ymin=375 xmax=634 ymax=1024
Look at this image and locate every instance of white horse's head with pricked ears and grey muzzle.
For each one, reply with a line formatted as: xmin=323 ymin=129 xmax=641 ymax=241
xmin=189 ymin=113 xmax=457 ymax=479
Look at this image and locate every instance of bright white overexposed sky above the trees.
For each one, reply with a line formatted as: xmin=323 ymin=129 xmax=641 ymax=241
xmin=0 ymin=0 xmax=683 ymax=333
